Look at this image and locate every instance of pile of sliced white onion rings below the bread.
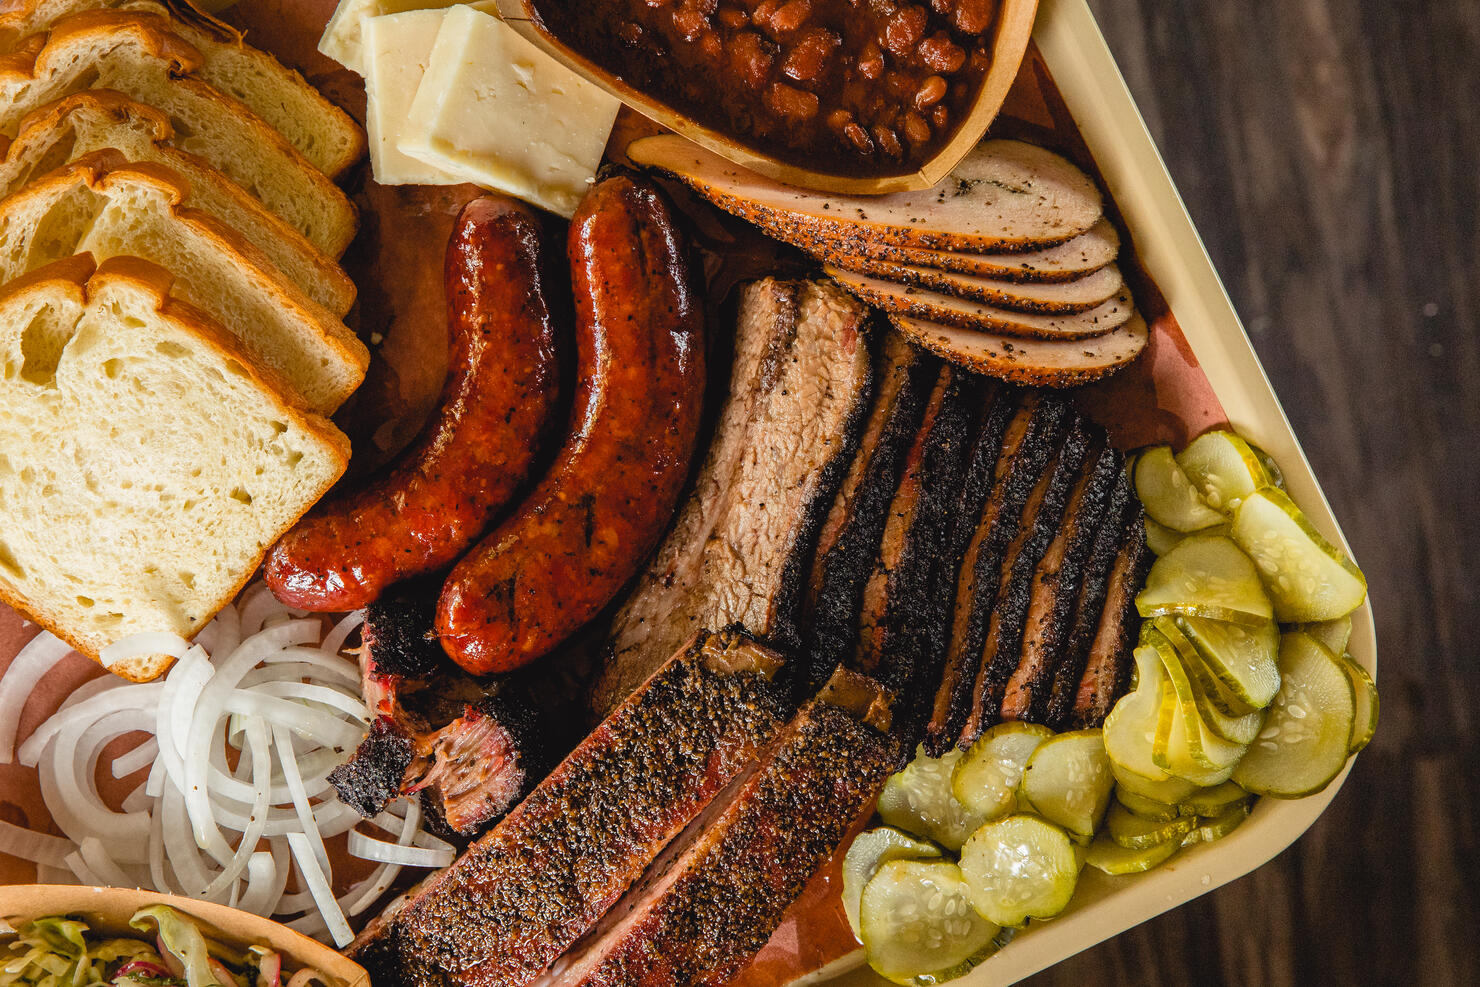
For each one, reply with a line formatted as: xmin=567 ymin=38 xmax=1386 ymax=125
xmin=0 ymin=585 xmax=453 ymax=944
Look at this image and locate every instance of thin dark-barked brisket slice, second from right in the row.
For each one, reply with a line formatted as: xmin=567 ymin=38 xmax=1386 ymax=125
xmin=1000 ymin=447 xmax=1125 ymax=722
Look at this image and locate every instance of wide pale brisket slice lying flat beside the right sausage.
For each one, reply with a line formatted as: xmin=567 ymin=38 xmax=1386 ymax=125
xmin=593 ymin=278 xmax=872 ymax=709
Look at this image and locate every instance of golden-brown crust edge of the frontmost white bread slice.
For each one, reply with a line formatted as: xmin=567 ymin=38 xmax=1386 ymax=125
xmin=0 ymin=253 xmax=349 ymax=682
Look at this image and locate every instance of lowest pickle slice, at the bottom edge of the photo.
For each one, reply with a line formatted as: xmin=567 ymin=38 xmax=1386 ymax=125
xmin=858 ymin=860 xmax=999 ymax=984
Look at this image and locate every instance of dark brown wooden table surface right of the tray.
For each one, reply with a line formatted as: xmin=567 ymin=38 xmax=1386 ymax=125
xmin=1030 ymin=0 xmax=1480 ymax=987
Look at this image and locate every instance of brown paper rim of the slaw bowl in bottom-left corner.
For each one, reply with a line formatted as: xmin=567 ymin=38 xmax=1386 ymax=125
xmin=0 ymin=885 xmax=370 ymax=987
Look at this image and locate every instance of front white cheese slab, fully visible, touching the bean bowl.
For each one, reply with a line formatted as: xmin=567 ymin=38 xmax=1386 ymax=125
xmin=397 ymin=7 xmax=622 ymax=218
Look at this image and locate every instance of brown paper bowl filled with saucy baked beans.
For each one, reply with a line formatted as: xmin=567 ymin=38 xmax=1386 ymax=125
xmin=497 ymin=0 xmax=1037 ymax=195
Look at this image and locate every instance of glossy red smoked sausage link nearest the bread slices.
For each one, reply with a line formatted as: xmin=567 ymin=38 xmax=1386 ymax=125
xmin=265 ymin=197 xmax=561 ymax=611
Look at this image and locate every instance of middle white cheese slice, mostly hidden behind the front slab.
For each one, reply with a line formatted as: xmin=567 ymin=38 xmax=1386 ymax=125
xmin=363 ymin=10 xmax=462 ymax=185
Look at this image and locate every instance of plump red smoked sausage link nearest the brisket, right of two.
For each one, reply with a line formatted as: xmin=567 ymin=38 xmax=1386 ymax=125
xmin=437 ymin=176 xmax=704 ymax=675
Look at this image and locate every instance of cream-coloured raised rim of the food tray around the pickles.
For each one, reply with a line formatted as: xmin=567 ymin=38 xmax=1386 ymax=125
xmin=827 ymin=0 xmax=1376 ymax=987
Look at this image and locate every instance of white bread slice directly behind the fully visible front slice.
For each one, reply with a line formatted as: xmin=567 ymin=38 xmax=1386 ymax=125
xmin=0 ymin=151 xmax=370 ymax=414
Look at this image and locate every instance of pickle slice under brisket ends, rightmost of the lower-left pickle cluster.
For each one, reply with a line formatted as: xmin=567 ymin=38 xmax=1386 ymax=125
xmin=1023 ymin=730 xmax=1114 ymax=839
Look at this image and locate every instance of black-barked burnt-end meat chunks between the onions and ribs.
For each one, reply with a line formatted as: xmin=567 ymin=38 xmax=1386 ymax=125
xmin=329 ymin=580 xmax=556 ymax=836
